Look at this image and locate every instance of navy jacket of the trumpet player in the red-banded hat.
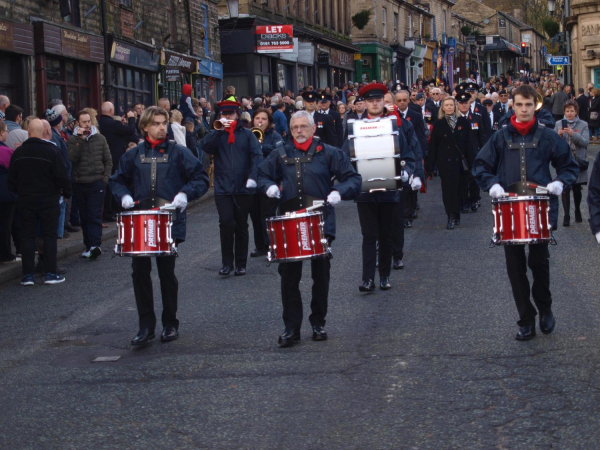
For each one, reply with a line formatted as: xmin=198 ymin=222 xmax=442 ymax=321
xmin=200 ymin=120 xmax=263 ymax=195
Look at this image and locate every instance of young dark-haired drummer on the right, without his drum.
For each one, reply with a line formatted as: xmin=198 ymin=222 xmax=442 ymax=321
xmin=473 ymin=84 xmax=578 ymax=341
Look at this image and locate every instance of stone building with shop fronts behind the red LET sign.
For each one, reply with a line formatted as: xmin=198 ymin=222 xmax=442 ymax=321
xmin=219 ymin=0 xmax=359 ymax=96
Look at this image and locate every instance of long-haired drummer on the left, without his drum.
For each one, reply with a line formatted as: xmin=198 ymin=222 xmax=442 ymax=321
xmin=109 ymin=106 xmax=209 ymax=346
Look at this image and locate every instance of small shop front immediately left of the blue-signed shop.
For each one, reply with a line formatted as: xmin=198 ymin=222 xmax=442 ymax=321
xmin=158 ymin=49 xmax=200 ymax=105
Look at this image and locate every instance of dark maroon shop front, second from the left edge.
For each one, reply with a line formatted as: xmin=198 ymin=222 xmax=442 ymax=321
xmin=33 ymin=22 xmax=104 ymax=116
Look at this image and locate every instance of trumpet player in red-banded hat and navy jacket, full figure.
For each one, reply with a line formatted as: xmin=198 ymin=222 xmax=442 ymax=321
xmin=201 ymin=100 xmax=262 ymax=276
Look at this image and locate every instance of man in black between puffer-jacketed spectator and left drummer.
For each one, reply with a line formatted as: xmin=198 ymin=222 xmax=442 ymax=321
xmin=98 ymin=102 xmax=137 ymax=222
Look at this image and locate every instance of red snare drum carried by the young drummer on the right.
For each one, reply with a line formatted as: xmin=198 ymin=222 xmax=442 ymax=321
xmin=492 ymin=196 xmax=552 ymax=245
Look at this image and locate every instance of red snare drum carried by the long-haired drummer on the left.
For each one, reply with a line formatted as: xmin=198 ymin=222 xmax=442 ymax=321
xmin=115 ymin=211 xmax=176 ymax=256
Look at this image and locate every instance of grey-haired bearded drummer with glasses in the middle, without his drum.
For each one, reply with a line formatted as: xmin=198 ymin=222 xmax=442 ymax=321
xmin=258 ymin=111 xmax=362 ymax=347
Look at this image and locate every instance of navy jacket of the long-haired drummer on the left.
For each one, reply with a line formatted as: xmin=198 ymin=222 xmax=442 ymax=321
xmin=108 ymin=141 xmax=209 ymax=242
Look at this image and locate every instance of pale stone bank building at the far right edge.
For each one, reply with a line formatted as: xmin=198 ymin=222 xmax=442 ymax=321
xmin=567 ymin=0 xmax=600 ymax=88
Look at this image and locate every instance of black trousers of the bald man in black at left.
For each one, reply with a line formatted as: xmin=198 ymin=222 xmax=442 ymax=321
xmin=17 ymin=203 xmax=60 ymax=275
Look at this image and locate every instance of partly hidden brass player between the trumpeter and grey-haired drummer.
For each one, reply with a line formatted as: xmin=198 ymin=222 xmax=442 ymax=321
xmin=250 ymin=108 xmax=283 ymax=258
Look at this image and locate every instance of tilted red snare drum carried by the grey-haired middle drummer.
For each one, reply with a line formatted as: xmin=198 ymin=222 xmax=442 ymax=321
xmin=267 ymin=211 xmax=331 ymax=262
